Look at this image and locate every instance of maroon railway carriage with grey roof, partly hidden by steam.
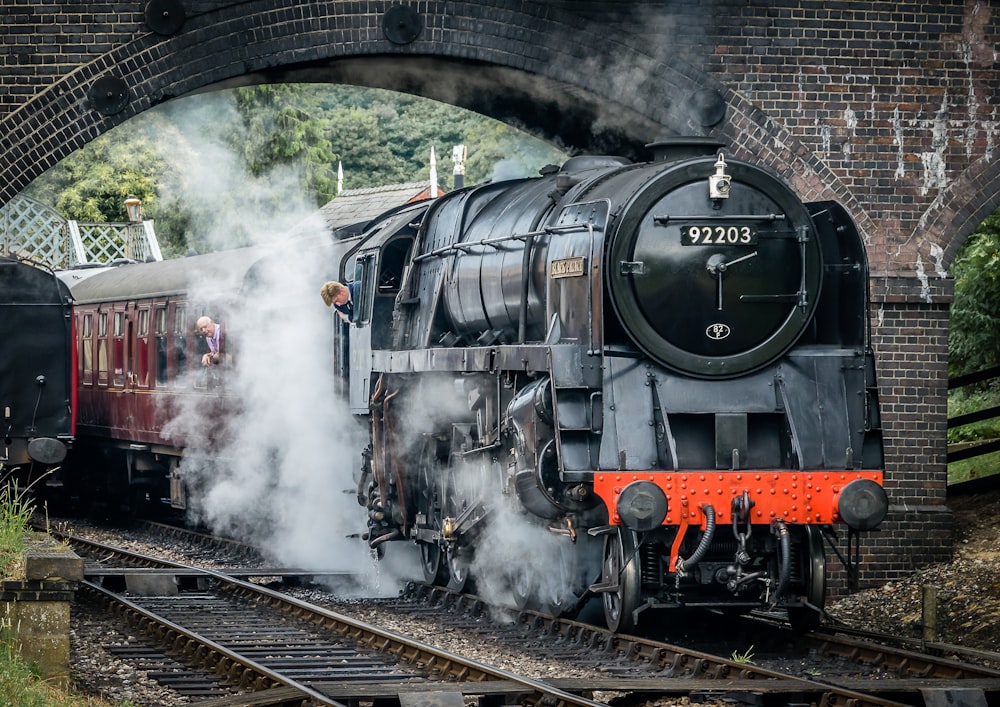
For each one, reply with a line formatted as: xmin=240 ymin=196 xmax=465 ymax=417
xmin=62 ymin=234 xmax=364 ymax=515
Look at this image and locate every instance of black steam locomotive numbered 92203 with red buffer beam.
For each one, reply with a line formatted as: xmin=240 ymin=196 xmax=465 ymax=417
xmin=342 ymin=139 xmax=888 ymax=630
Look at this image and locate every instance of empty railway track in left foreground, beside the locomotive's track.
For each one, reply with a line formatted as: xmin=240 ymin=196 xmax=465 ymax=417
xmin=61 ymin=535 xmax=612 ymax=707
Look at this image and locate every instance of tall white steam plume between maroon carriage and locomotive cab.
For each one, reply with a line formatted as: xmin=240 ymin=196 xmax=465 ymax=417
xmin=150 ymin=91 xmax=419 ymax=594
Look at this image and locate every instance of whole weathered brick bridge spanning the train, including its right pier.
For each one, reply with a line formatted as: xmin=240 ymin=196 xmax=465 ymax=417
xmin=0 ymin=0 xmax=1000 ymax=578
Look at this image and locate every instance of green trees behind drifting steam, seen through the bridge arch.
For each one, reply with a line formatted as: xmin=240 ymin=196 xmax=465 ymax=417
xmin=25 ymin=84 xmax=566 ymax=257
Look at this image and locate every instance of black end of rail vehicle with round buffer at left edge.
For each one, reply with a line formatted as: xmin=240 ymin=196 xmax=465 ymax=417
xmin=0 ymin=256 xmax=76 ymax=489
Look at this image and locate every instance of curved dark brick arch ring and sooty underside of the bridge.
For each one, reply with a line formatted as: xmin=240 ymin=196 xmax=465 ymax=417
xmin=0 ymin=0 xmax=844 ymax=215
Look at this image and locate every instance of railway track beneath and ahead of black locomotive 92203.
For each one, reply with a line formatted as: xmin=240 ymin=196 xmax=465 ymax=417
xmin=388 ymin=583 xmax=1000 ymax=705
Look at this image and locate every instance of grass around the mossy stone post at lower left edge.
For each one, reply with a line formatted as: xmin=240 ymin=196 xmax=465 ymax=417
xmin=0 ymin=466 xmax=132 ymax=707
